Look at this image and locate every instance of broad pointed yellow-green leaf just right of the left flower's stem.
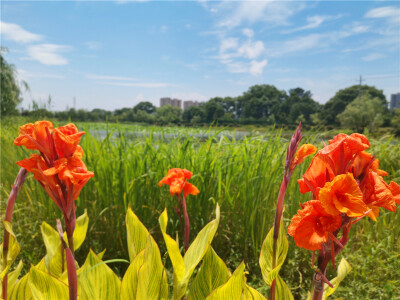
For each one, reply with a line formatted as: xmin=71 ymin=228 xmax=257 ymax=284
xmin=77 ymin=250 xmax=121 ymax=300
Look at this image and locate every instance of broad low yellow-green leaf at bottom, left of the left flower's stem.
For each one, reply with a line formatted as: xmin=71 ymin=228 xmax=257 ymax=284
xmin=28 ymin=266 xmax=69 ymax=300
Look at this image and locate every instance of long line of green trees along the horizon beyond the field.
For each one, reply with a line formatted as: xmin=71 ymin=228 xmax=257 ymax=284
xmin=1 ymin=49 xmax=400 ymax=133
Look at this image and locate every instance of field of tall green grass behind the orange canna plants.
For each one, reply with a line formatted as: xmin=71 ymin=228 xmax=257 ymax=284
xmin=1 ymin=118 xmax=400 ymax=299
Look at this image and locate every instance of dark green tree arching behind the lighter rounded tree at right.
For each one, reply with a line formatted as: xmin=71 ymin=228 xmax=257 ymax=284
xmin=320 ymin=85 xmax=387 ymax=125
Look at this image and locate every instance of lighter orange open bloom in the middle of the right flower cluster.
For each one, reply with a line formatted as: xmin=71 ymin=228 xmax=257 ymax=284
xmin=319 ymin=173 xmax=369 ymax=217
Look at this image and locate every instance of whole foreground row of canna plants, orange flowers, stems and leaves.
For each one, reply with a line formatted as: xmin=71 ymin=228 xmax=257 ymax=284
xmin=0 ymin=121 xmax=400 ymax=300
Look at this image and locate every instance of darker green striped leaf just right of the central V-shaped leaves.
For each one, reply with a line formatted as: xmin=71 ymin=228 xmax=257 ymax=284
xmin=189 ymin=246 xmax=230 ymax=300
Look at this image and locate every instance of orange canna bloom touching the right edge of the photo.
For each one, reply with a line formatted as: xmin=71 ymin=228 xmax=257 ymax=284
xmin=360 ymin=171 xmax=398 ymax=221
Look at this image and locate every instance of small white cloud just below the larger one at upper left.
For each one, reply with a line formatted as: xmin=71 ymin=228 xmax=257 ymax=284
xmin=27 ymin=44 xmax=70 ymax=66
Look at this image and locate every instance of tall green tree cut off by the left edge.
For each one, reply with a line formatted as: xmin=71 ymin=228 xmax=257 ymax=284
xmin=0 ymin=47 xmax=28 ymax=115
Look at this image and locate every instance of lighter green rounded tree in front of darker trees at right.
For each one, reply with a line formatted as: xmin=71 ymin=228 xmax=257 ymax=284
xmin=338 ymin=95 xmax=384 ymax=132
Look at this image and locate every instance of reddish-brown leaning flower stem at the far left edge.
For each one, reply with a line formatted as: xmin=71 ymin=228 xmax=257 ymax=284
xmin=2 ymin=168 xmax=27 ymax=299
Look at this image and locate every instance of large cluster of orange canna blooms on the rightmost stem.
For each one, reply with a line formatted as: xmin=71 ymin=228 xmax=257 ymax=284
xmin=288 ymin=133 xmax=400 ymax=296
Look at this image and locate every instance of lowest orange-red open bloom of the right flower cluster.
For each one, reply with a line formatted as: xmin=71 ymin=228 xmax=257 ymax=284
xmin=288 ymin=200 xmax=342 ymax=250
